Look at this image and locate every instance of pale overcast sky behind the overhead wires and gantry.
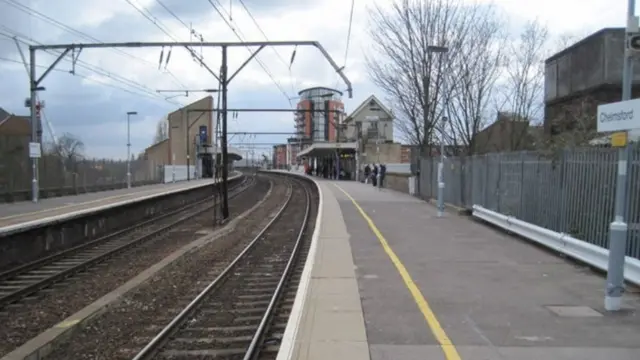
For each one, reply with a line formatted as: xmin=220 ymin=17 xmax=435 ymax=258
xmin=0 ymin=0 xmax=626 ymax=158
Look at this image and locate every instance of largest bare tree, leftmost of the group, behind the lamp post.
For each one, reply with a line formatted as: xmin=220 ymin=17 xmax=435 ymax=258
xmin=366 ymin=0 xmax=484 ymax=149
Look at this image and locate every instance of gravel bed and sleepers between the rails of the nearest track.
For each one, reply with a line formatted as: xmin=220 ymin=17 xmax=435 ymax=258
xmin=149 ymin=179 xmax=315 ymax=360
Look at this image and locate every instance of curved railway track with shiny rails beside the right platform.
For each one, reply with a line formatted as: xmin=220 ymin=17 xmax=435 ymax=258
xmin=127 ymin=176 xmax=311 ymax=360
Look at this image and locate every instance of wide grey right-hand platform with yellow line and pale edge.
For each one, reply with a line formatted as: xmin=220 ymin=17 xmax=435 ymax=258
xmin=278 ymin=174 xmax=640 ymax=360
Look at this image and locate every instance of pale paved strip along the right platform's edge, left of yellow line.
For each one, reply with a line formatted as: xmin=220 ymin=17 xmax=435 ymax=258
xmin=278 ymin=180 xmax=370 ymax=360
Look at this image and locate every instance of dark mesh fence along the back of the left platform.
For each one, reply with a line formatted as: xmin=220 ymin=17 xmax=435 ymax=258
xmin=0 ymin=153 xmax=163 ymax=202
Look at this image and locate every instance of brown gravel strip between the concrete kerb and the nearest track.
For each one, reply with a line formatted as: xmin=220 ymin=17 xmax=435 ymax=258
xmin=47 ymin=176 xmax=287 ymax=360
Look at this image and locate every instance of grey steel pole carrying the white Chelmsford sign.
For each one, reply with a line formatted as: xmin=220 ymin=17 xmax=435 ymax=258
xmin=604 ymin=0 xmax=636 ymax=311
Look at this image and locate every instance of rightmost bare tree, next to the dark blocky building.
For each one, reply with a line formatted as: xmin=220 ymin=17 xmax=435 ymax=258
xmin=496 ymin=21 xmax=549 ymax=149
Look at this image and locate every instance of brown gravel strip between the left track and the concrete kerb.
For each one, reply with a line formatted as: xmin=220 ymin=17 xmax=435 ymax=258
xmin=0 ymin=175 xmax=270 ymax=359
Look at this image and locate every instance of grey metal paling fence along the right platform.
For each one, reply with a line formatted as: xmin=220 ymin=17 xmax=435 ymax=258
xmin=417 ymin=148 xmax=640 ymax=258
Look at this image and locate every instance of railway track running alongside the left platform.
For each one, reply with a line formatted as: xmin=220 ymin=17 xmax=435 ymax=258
xmin=0 ymin=176 xmax=255 ymax=309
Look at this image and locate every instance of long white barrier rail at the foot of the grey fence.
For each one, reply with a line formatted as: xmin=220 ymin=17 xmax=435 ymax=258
xmin=473 ymin=205 xmax=640 ymax=285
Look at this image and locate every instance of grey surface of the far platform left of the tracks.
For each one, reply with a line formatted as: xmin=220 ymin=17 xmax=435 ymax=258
xmin=0 ymin=179 xmax=218 ymax=228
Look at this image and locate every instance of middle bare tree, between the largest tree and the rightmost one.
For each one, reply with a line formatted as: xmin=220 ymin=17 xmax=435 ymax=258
xmin=442 ymin=6 xmax=507 ymax=155
